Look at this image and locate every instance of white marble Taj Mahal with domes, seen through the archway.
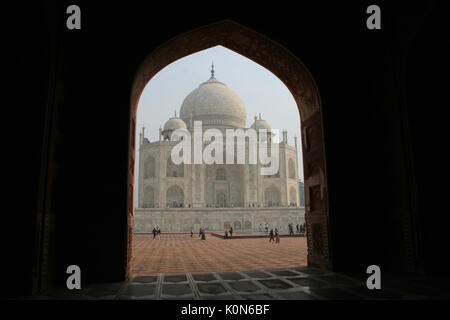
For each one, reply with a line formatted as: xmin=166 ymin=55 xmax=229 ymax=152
xmin=134 ymin=66 xmax=304 ymax=232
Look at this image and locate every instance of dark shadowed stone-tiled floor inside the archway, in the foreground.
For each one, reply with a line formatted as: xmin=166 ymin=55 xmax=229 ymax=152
xmin=30 ymin=267 xmax=450 ymax=300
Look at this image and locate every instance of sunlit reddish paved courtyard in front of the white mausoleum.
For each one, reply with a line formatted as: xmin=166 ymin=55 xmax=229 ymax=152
xmin=133 ymin=234 xmax=307 ymax=277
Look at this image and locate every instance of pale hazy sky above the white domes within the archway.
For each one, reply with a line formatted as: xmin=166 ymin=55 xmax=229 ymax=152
xmin=135 ymin=46 xmax=303 ymax=205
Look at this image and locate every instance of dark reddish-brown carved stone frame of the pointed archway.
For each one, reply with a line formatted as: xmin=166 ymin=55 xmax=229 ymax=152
xmin=126 ymin=20 xmax=332 ymax=277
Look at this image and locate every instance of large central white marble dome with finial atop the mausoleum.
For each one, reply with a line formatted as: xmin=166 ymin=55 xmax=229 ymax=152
xmin=180 ymin=69 xmax=247 ymax=128
